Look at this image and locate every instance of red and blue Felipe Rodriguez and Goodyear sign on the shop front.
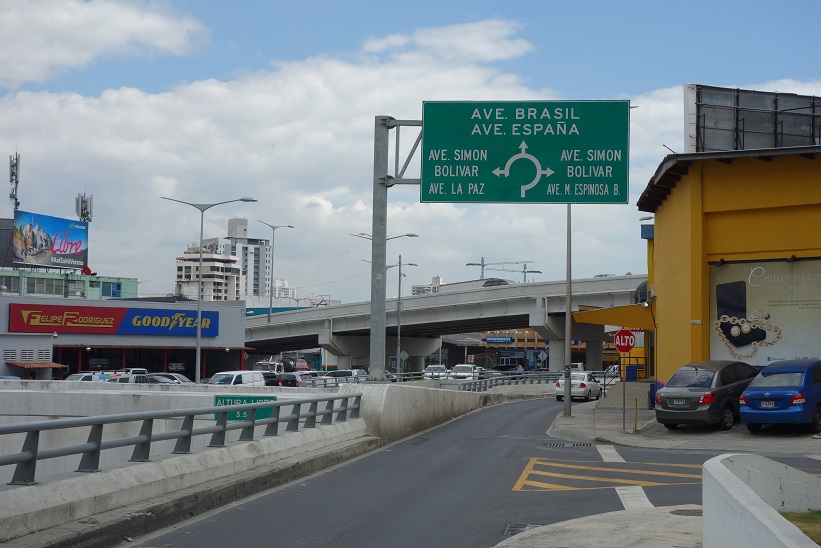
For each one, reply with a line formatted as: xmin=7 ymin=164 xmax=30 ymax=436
xmin=9 ymin=303 xmax=219 ymax=337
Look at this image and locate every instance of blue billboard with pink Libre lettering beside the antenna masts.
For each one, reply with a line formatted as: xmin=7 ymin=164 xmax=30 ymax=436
xmin=12 ymin=209 xmax=88 ymax=269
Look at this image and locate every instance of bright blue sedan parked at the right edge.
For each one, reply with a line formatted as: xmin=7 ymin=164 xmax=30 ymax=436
xmin=739 ymin=360 xmax=821 ymax=433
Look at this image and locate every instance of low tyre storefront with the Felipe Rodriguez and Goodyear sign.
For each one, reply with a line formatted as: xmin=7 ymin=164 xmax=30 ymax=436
xmin=0 ymin=296 xmax=246 ymax=379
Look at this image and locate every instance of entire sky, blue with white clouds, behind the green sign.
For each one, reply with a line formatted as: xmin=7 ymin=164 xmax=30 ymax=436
xmin=0 ymin=0 xmax=821 ymax=302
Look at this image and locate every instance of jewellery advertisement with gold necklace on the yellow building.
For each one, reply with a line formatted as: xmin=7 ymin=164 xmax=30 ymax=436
xmin=710 ymin=260 xmax=821 ymax=366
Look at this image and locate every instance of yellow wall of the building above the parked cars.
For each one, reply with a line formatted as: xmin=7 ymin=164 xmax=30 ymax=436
xmin=650 ymin=155 xmax=821 ymax=382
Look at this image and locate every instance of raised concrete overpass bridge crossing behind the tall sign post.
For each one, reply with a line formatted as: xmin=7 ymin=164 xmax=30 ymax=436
xmin=245 ymin=275 xmax=647 ymax=371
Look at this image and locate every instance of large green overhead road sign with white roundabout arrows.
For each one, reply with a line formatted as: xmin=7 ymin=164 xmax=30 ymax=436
xmin=421 ymin=101 xmax=630 ymax=204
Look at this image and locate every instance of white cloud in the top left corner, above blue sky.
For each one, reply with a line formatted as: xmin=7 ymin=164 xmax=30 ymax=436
xmin=0 ymin=0 xmax=207 ymax=89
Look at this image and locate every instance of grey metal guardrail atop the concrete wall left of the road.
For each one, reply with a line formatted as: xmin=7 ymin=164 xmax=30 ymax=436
xmin=0 ymin=394 xmax=362 ymax=485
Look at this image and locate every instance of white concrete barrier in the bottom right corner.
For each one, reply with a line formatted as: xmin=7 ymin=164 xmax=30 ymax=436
xmin=702 ymin=454 xmax=821 ymax=548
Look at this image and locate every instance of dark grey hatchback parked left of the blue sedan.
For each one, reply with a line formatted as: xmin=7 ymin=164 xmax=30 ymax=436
xmin=656 ymin=360 xmax=758 ymax=430
